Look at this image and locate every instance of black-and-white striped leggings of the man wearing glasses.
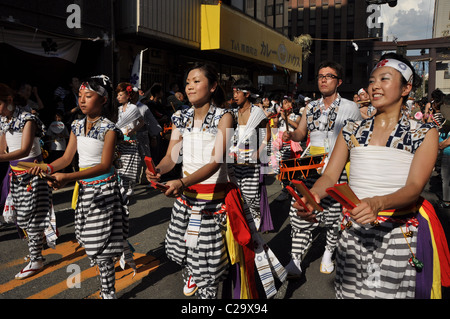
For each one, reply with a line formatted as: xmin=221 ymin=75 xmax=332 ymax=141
xmin=289 ymin=171 xmax=347 ymax=260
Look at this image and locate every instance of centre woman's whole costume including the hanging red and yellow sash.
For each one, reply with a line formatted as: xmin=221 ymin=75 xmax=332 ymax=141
xmin=165 ymin=105 xmax=286 ymax=299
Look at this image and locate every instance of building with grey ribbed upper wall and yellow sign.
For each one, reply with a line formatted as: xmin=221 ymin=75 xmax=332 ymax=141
xmin=116 ymin=0 xmax=302 ymax=97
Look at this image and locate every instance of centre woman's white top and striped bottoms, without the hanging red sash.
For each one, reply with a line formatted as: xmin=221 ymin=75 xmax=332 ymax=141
xmin=165 ymin=105 xmax=229 ymax=299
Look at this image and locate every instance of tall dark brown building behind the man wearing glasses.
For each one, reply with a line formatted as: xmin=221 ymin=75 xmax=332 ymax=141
xmin=288 ymin=0 xmax=372 ymax=97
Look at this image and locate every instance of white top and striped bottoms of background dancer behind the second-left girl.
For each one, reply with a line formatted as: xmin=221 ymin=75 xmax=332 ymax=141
xmin=117 ymin=103 xmax=141 ymax=195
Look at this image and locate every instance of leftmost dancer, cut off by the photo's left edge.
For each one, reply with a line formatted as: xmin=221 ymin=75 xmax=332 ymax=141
xmin=0 ymin=83 xmax=56 ymax=279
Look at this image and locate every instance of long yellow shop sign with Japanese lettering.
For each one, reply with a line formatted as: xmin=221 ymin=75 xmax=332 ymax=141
xmin=201 ymin=4 xmax=302 ymax=72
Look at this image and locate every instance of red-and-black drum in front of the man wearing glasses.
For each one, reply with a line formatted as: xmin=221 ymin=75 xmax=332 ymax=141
xmin=278 ymin=153 xmax=328 ymax=181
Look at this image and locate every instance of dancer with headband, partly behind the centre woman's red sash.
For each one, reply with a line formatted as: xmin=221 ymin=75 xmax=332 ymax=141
xmin=228 ymin=79 xmax=287 ymax=298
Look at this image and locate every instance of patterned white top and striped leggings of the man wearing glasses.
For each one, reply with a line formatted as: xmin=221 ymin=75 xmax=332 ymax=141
xmin=289 ymin=94 xmax=361 ymax=273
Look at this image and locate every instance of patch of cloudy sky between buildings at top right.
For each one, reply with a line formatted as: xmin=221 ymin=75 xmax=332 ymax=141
xmin=380 ymin=0 xmax=434 ymax=41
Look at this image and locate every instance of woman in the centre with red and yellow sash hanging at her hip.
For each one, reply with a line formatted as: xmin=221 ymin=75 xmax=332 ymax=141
xmin=146 ymin=64 xmax=284 ymax=299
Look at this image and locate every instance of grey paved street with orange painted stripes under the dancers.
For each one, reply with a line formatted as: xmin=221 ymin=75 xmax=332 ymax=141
xmin=0 ymin=172 xmax=450 ymax=300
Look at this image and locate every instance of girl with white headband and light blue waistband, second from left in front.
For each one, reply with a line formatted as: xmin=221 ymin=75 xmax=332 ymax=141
xmin=32 ymin=75 xmax=135 ymax=299
